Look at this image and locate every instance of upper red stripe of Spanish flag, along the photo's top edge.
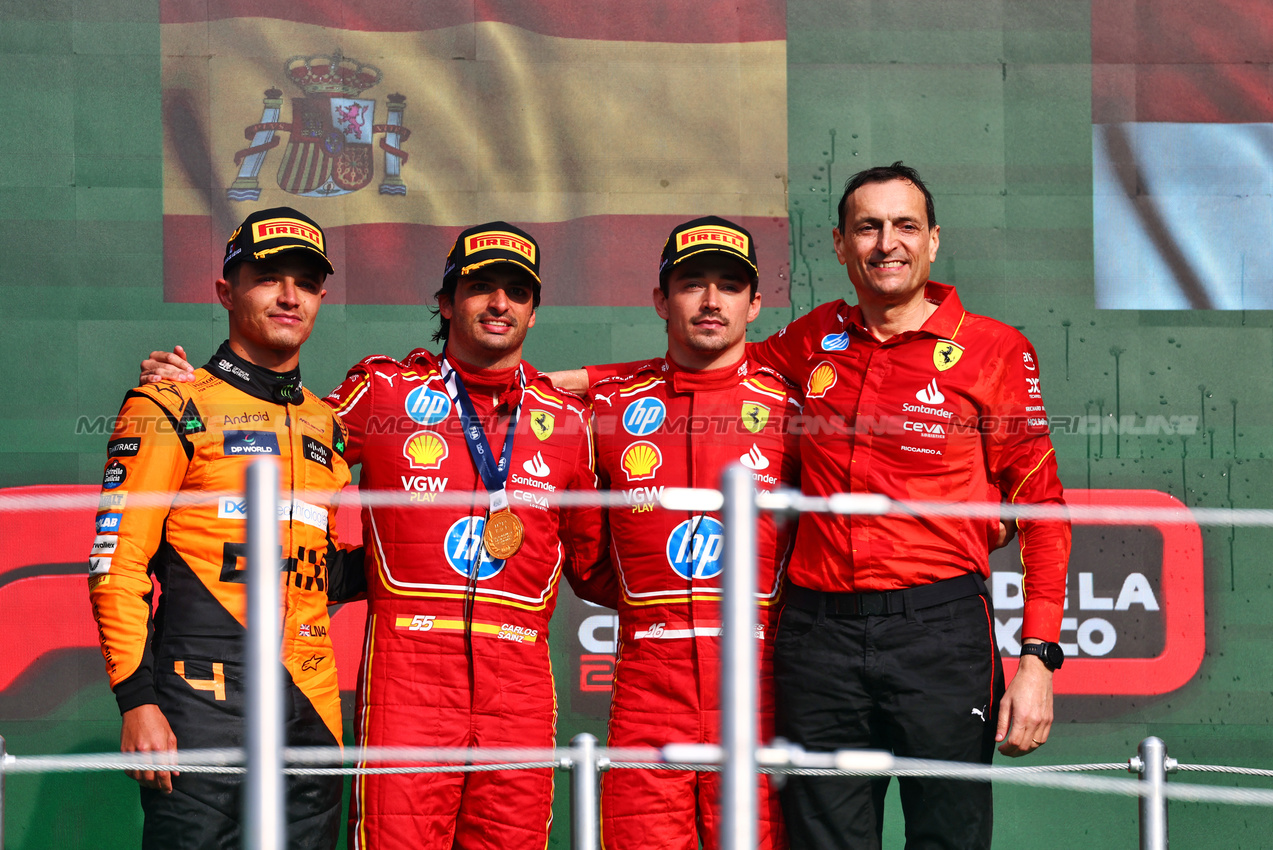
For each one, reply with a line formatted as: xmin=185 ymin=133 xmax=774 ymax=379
xmin=159 ymin=0 xmax=787 ymax=43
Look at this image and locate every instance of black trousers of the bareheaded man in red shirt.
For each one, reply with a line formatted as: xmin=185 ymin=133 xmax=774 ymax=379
xmin=774 ymin=587 xmax=1003 ymax=850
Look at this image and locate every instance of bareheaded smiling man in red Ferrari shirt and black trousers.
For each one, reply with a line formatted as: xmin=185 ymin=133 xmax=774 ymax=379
xmin=751 ymin=163 xmax=1069 ymax=849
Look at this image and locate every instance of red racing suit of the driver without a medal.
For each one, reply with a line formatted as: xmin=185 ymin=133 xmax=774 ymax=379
xmin=589 ymin=360 xmax=799 ymax=850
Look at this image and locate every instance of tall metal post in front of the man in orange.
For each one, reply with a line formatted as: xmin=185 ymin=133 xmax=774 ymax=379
xmin=243 ymin=458 xmax=286 ymax=850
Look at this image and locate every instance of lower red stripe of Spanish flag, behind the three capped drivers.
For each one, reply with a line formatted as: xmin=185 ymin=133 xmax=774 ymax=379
xmin=164 ymin=210 xmax=791 ymax=307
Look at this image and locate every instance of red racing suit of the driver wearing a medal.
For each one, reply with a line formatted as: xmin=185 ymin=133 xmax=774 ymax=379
xmin=328 ymin=349 xmax=614 ymax=850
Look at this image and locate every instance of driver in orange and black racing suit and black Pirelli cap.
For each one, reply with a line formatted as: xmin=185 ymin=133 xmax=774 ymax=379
xmin=89 ymin=207 xmax=365 ymax=850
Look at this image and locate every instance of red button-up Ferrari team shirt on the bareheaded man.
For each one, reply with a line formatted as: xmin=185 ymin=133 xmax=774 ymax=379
xmin=749 ymin=282 xmax=1069 ymax=641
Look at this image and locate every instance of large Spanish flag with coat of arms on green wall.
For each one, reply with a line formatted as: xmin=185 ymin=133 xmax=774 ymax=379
xmin=159 ymin=0 xmax=789 ymax=307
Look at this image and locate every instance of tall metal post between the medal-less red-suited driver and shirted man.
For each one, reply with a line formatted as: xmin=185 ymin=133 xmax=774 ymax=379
xmin=721 ymin=463 xmax=757 ymax=850
